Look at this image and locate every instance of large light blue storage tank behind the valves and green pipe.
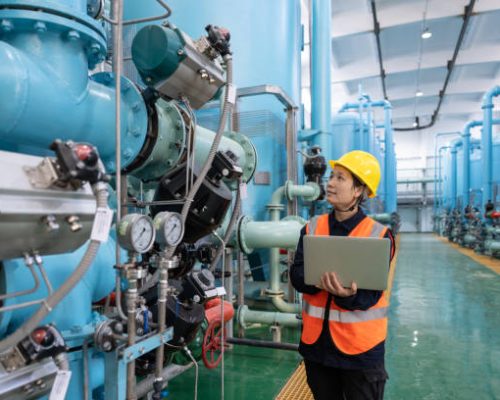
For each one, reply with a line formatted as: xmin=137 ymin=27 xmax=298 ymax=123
xmin=124 ymin=0 xmax=302 ymax=220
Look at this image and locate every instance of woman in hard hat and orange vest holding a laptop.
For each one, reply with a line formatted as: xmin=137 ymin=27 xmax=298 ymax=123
xmin=290 ymin=150 xmax=395 ymax=400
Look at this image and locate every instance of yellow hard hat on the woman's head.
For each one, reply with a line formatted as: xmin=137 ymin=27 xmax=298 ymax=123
xmin=329 ymin=150 xmax=380 ymax=198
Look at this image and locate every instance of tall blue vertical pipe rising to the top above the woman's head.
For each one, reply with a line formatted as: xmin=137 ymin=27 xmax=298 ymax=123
xmin=311 ymin=0 xmax=332 ymax=160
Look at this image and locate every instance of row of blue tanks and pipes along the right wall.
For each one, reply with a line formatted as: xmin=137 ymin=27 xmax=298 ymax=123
xmin=434 ymin=86 xmax=500 ymax=258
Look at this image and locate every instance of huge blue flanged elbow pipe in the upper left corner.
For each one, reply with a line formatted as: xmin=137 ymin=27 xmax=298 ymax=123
xmin=0 ymin=0 xmax=148 ymax=172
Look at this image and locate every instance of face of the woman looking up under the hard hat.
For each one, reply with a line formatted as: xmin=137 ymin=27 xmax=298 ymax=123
xmin=326 ymin=165 xmax=363 ymax=209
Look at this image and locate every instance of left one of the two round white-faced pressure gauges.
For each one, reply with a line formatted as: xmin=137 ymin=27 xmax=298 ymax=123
xmin=118 ymin=214 xmax=155 ymax=254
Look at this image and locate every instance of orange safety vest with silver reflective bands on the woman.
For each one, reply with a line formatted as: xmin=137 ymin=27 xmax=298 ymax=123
xmin=301 ymin=214 xmax=389 ymax=355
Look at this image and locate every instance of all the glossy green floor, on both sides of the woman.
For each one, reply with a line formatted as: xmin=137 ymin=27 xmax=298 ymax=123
xmin=167 ymin=234 xmax=500 ymax=400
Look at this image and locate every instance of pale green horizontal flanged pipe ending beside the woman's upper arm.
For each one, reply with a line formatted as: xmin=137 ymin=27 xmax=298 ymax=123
xmin=238 ymin=216 xmax=306 ymax=254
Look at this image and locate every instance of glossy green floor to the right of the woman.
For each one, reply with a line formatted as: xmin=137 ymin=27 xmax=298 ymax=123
xmin=386 ymin=234 xmax=500 ymax=400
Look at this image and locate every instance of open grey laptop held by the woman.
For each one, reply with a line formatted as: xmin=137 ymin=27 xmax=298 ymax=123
xmin=304 ymin=235 xmax=391 ymax=290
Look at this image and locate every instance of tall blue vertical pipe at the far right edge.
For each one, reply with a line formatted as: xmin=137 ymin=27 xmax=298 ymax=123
xmin=481 ymin=86 xmax=500 ymax=207
